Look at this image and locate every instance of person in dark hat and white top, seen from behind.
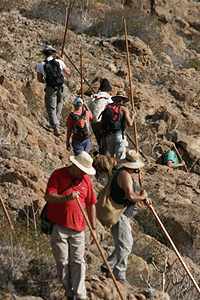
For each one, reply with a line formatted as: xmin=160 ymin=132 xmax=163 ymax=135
xmin=87 ymin=78 xmax=113 ymax=155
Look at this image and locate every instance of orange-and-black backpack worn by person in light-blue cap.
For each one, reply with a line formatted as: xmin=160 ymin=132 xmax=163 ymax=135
xmin=70 ymin=110 xmax=90 ymax=140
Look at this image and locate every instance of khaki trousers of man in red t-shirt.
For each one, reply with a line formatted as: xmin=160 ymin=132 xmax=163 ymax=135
xmin=51 ymin=224 xmax=86 ymax=299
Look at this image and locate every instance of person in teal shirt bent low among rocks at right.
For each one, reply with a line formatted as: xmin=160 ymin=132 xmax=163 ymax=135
xmin=156 ymin=141 xmax=187 ymax=170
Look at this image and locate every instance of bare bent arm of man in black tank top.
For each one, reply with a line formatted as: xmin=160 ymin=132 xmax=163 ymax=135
xmin=117 ymin=171 xmax=148 ymax=202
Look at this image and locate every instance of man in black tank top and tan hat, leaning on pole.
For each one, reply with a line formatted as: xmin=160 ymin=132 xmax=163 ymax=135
xmin=101 ymin=150 xmax=151 ymax=282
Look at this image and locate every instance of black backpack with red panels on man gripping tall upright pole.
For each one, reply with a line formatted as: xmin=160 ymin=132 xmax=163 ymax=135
xmin=101 ymin=103 xmax=122 ymax=133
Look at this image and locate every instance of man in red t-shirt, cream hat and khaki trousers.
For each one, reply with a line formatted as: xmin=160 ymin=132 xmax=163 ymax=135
xmin=44 ymin=151 xmax=97 ymax=300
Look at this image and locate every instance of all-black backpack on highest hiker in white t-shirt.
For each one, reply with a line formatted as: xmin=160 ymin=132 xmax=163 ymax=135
xmin=44 ymin=58 xmax=64 ymax=87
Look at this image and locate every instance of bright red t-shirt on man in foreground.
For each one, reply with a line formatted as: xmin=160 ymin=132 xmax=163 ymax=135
xmin=46 ymin=167 xmax=97 ymax=231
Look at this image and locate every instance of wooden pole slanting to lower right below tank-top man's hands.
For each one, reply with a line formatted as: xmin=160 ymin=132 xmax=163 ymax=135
xmin=148 ymin=204 xmax=200 ymax=295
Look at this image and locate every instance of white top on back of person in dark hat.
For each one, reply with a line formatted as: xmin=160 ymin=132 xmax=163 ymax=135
xmin=88 ymin=92 xmax=112 ymax=123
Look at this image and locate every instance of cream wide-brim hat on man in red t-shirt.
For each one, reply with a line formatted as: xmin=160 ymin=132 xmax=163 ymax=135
xmin=69 ymin=151 xmax=96 ymax=175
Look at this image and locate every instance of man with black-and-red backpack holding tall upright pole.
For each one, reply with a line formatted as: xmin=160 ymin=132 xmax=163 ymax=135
xmin=101 ymin=92 xmax=136 ymax=159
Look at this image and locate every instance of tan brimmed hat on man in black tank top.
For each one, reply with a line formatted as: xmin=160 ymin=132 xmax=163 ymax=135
xmin=119 ymin=150 xmax=145 ymax=169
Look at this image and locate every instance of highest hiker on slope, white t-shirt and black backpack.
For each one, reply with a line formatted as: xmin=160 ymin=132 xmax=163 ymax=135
xmin=36 ymin=45 xmax=70 ymax=136
